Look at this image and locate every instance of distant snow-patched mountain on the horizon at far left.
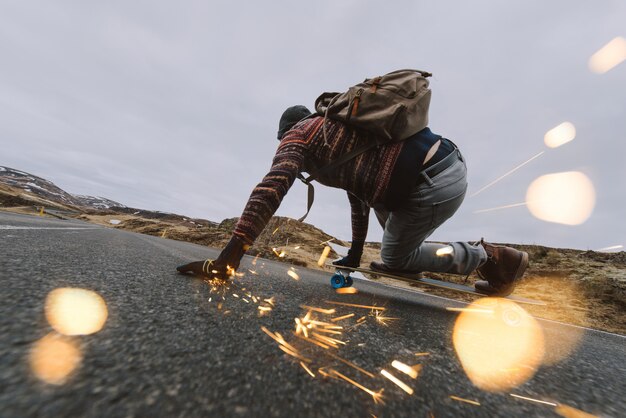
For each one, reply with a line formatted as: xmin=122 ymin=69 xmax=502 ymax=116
xmin=0 ymin=166 xmax=126 ymax=210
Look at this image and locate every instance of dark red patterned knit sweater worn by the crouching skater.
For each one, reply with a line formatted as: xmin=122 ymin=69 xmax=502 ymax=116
xmin=234 ymin=117 xmax=404 ymax=245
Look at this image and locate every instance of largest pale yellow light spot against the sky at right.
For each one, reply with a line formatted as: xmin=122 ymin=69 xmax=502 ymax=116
xmin=526 ymin=171 xmax=596 ymax=225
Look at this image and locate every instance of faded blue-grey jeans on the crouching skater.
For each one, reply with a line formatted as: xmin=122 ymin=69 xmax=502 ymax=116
xmin=374 ymin=150 xmax=487 ymax=275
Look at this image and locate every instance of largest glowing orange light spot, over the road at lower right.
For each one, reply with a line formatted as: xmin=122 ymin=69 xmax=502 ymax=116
xmin=453 ymin=298 xmax=544 ymax=392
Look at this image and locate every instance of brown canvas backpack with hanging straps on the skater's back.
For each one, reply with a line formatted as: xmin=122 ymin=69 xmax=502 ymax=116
xmin=298 ymin=70 xmax=432 ymax=221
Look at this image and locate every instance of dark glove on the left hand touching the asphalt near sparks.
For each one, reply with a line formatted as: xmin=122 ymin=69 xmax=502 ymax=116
xmin=176 ymin=236 xmax=250 ymax=280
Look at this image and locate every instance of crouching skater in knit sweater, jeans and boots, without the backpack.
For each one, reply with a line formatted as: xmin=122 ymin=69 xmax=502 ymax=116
xmin=177 ymin=105 xmax=528 ymax=296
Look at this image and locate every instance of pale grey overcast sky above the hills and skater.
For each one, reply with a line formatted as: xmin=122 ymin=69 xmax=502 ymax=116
xmin=0 ymin=0 xmax=626 ymax=249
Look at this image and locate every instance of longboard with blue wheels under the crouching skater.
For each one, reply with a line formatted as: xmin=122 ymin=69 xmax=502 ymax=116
xmin=328 ymin=264 xmax=546 ymax=305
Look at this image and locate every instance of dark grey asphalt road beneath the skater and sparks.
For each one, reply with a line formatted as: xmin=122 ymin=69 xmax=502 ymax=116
xmin=0 ymin=213 xmax=626 ymax=418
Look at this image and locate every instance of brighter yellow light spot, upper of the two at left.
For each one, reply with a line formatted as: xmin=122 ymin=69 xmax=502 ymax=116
xmin=45 ymin=288 xmax=108 ymax=335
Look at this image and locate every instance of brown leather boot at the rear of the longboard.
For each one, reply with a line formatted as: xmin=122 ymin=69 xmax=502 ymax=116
xmin=474 ymin=239 xmax=528 ymax=296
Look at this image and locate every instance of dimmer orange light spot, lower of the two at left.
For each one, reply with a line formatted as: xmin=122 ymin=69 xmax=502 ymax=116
xmin=29 ymin=333 xmax=83 ymax=385
